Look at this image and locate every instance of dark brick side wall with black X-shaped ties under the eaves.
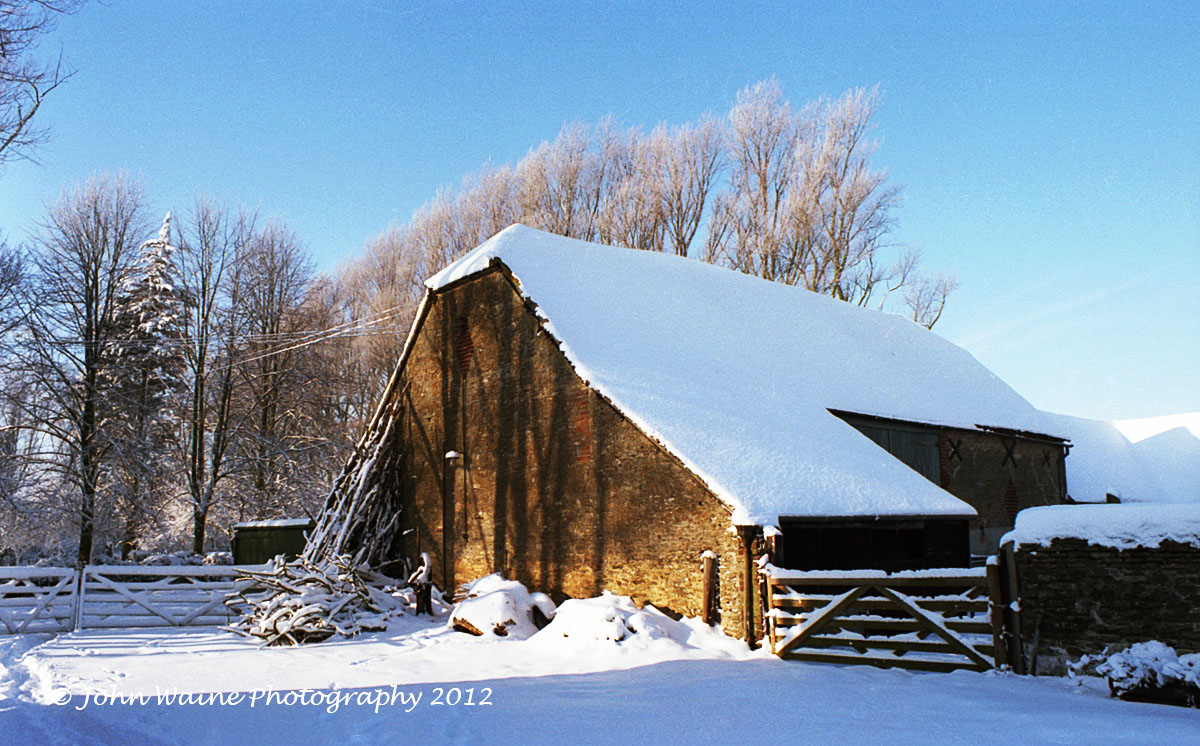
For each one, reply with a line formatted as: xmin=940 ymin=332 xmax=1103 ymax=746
xmin=938 ymin=429 xmax=1066 ymax=554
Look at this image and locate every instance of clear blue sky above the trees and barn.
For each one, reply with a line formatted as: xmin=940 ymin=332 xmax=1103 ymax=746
xmin=0 ymin=0 xmax=1200 ymax=419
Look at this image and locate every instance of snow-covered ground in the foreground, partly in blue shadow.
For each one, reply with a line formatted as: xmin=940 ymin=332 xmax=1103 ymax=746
xmin=0 ymin=618 xmax=1200 ymax=745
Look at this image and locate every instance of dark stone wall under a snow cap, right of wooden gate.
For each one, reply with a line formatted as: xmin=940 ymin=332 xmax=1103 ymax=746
xmin=1014 ymin=539 xmax=1200 ymax=673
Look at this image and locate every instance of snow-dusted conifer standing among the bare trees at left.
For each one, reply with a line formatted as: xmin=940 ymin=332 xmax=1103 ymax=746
xmin=102 ymin=213 xmax=186 ymax=557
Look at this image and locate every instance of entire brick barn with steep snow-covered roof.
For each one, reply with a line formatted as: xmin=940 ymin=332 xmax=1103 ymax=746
xmin=362 ymin=225 xmax=1067 ymax=633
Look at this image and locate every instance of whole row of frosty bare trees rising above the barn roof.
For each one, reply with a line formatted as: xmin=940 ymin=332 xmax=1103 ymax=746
xmin=338 ymin=78 xmax=955 ymax=338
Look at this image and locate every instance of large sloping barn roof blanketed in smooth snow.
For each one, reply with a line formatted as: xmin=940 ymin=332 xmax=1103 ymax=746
xmin=426 ymin=225 xmax=1065 ymax=524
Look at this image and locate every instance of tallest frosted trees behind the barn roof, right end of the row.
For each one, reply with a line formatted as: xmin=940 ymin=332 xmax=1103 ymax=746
xmin=706 ymin=79 xmax=956 ymax=326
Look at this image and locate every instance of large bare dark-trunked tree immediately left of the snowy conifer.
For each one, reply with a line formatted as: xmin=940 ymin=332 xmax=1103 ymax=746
xmin=24 ymin=174 xmax=148 ymax=562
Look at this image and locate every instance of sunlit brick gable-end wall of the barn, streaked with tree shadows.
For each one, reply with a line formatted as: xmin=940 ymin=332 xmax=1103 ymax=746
xmin=400 ymin=271 xmax=740 ymax=634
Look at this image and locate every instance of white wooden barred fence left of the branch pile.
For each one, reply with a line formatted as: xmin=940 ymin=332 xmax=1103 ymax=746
xmin=0 ymin=565 xmax=258 ymax=634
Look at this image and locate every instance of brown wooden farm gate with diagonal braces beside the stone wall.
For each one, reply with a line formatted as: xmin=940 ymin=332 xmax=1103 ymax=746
xmin=761 ymin=565 xmax=1007 ymax=672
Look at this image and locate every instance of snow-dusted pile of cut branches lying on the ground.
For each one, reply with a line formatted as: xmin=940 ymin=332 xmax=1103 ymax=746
xmin=226 ymin=557 xmax=398 ymax=645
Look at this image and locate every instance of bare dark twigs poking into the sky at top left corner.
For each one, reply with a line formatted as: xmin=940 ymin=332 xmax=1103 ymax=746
xmin=0 ymin=0 xmax=79 ymax=164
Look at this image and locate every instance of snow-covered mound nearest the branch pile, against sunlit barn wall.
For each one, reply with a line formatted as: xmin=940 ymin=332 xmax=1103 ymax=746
xmin=449 ymin=573 xmax=556 ymax=639
